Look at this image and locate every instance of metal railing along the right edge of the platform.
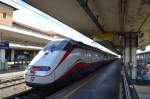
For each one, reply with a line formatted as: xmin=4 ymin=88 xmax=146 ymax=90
xmin=119 ymin=66 xmax=139 ymax=99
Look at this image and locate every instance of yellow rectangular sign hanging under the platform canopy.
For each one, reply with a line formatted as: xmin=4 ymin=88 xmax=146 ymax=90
xmin=94 ymin=33 xmax=113 ymax=40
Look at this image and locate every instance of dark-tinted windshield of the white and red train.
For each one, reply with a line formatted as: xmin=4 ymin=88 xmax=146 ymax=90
xmin=43 ymin=40 xmax=68 ymax=51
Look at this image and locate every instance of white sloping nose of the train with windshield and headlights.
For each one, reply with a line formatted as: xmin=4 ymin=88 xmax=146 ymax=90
xmin=25 ymin=41 xmax=67 ymax=87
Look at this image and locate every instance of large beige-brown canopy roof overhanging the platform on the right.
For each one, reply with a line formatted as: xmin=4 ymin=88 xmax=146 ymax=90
xmin=4 ymin=0 xmax=150 ymax=52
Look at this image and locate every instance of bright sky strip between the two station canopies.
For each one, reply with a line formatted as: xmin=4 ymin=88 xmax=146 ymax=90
xmin=1 ymin=0 xmax=119 ymax=54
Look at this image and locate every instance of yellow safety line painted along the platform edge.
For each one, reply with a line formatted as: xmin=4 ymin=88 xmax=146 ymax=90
xmin=62 ymin=73 xmax=97 ymax=99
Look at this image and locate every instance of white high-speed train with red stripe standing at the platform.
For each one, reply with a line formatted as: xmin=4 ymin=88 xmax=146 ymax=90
xmin=25 ymin=39 xmax=115 ymax=87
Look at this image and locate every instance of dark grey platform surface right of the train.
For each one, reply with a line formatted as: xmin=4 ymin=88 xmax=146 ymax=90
xmin=47 ymin=61 xmax=121 ymax=99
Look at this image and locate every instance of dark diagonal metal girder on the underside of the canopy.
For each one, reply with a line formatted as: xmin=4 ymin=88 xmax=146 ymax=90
xmin=77 ymin=0 xmax=104 ymax=32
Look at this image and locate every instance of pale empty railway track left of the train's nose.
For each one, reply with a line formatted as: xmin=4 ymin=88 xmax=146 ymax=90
xmin=0 ymin=77 xmax=25 ymax=90
